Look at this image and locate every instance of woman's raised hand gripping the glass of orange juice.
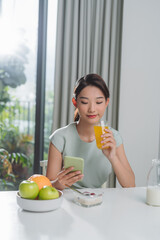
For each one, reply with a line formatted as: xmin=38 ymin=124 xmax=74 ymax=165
xmin=101 ymin=129 xmax=116 ymax=162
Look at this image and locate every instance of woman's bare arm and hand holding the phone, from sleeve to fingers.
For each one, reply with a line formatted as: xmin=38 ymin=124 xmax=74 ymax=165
xmin=46 ymin=143 xmax=83 ymax=190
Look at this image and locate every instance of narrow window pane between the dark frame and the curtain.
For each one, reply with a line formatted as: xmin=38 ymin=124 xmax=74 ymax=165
xmin=44 ymin=0 xmax=57 ymax=159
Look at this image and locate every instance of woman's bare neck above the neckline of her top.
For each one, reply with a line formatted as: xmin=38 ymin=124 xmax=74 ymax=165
xmin=76 ymin=121 xmax=95 ymax=142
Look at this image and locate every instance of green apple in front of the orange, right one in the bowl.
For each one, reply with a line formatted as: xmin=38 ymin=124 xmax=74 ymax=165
xmin=38 ymin=186 xmax=59 ymax=200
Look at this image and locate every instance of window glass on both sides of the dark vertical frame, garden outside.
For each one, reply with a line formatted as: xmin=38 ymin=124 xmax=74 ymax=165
xmin=0 ymin=0 xmax=57 ymax=190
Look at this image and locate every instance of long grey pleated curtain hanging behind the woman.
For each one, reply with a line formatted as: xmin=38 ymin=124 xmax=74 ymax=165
xmin=53 ymin=0 xmax=123 ymax=186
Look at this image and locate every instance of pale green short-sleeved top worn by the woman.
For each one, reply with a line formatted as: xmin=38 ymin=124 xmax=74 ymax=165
xmin=49 ymin=122 xmax=122 ymax=188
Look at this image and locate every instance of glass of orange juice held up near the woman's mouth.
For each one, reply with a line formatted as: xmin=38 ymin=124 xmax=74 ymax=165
xmin=94 ymin=121 xmax=109 ymax=149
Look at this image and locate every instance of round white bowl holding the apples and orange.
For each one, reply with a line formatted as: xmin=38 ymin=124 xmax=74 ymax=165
xmin=16 ymin=190 xmax=63 ymax=212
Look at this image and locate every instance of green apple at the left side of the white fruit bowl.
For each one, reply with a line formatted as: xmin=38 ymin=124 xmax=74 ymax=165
xmin=19 ymin=180 xmax=39 ymax=199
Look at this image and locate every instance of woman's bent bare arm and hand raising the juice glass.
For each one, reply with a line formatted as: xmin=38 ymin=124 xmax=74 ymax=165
xmin=103 ymin=130 xmax=135 ymax=187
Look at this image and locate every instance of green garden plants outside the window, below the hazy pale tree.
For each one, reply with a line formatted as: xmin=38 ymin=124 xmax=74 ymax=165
xmin=0 ymin=121 xmax=33 ymax=190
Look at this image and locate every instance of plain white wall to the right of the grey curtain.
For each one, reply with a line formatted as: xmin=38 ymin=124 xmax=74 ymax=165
xmin=119 ymin=0 xmax=160 ymax=186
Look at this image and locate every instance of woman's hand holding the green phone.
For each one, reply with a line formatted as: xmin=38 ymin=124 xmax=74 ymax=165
xmin=57 ymin=167 xmax=84 ymax=186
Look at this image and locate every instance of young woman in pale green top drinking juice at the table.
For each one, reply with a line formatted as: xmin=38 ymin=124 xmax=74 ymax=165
xmin=47 ymin=74 xmax=135 ymax=190
